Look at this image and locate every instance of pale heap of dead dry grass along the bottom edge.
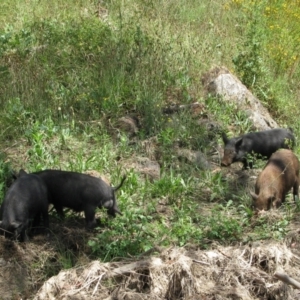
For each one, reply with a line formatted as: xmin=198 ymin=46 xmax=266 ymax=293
xmin=34 ymin=242 xmax=300 ymax=300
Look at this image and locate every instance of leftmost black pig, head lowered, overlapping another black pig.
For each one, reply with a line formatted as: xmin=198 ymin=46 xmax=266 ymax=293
xmin=0 ymin=171 xmax=49 ymax=241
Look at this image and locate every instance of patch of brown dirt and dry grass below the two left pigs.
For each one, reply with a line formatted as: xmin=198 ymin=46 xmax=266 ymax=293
xmin=0 ymin=216 xmax=101 ymax=300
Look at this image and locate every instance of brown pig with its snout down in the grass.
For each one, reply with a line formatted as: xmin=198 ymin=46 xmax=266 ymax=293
xmin=251 ymin=149 xmax=300 ymax=210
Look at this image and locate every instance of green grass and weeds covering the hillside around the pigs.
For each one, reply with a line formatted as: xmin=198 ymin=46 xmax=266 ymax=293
xmin=0 ymin=0 xmax=300 ymax=272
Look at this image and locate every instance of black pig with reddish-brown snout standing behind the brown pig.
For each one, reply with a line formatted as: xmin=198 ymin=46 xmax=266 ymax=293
xmin=221 ymin=128 xmax=295 ymax=169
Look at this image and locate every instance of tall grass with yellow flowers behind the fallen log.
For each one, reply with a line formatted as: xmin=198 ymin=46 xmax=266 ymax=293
xmin=229 ymin=0 xmax=300 ymax=125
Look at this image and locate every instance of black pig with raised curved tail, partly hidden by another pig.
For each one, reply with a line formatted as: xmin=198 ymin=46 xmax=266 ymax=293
xmin=34 ymin=170 xmax=126 ymax=228
